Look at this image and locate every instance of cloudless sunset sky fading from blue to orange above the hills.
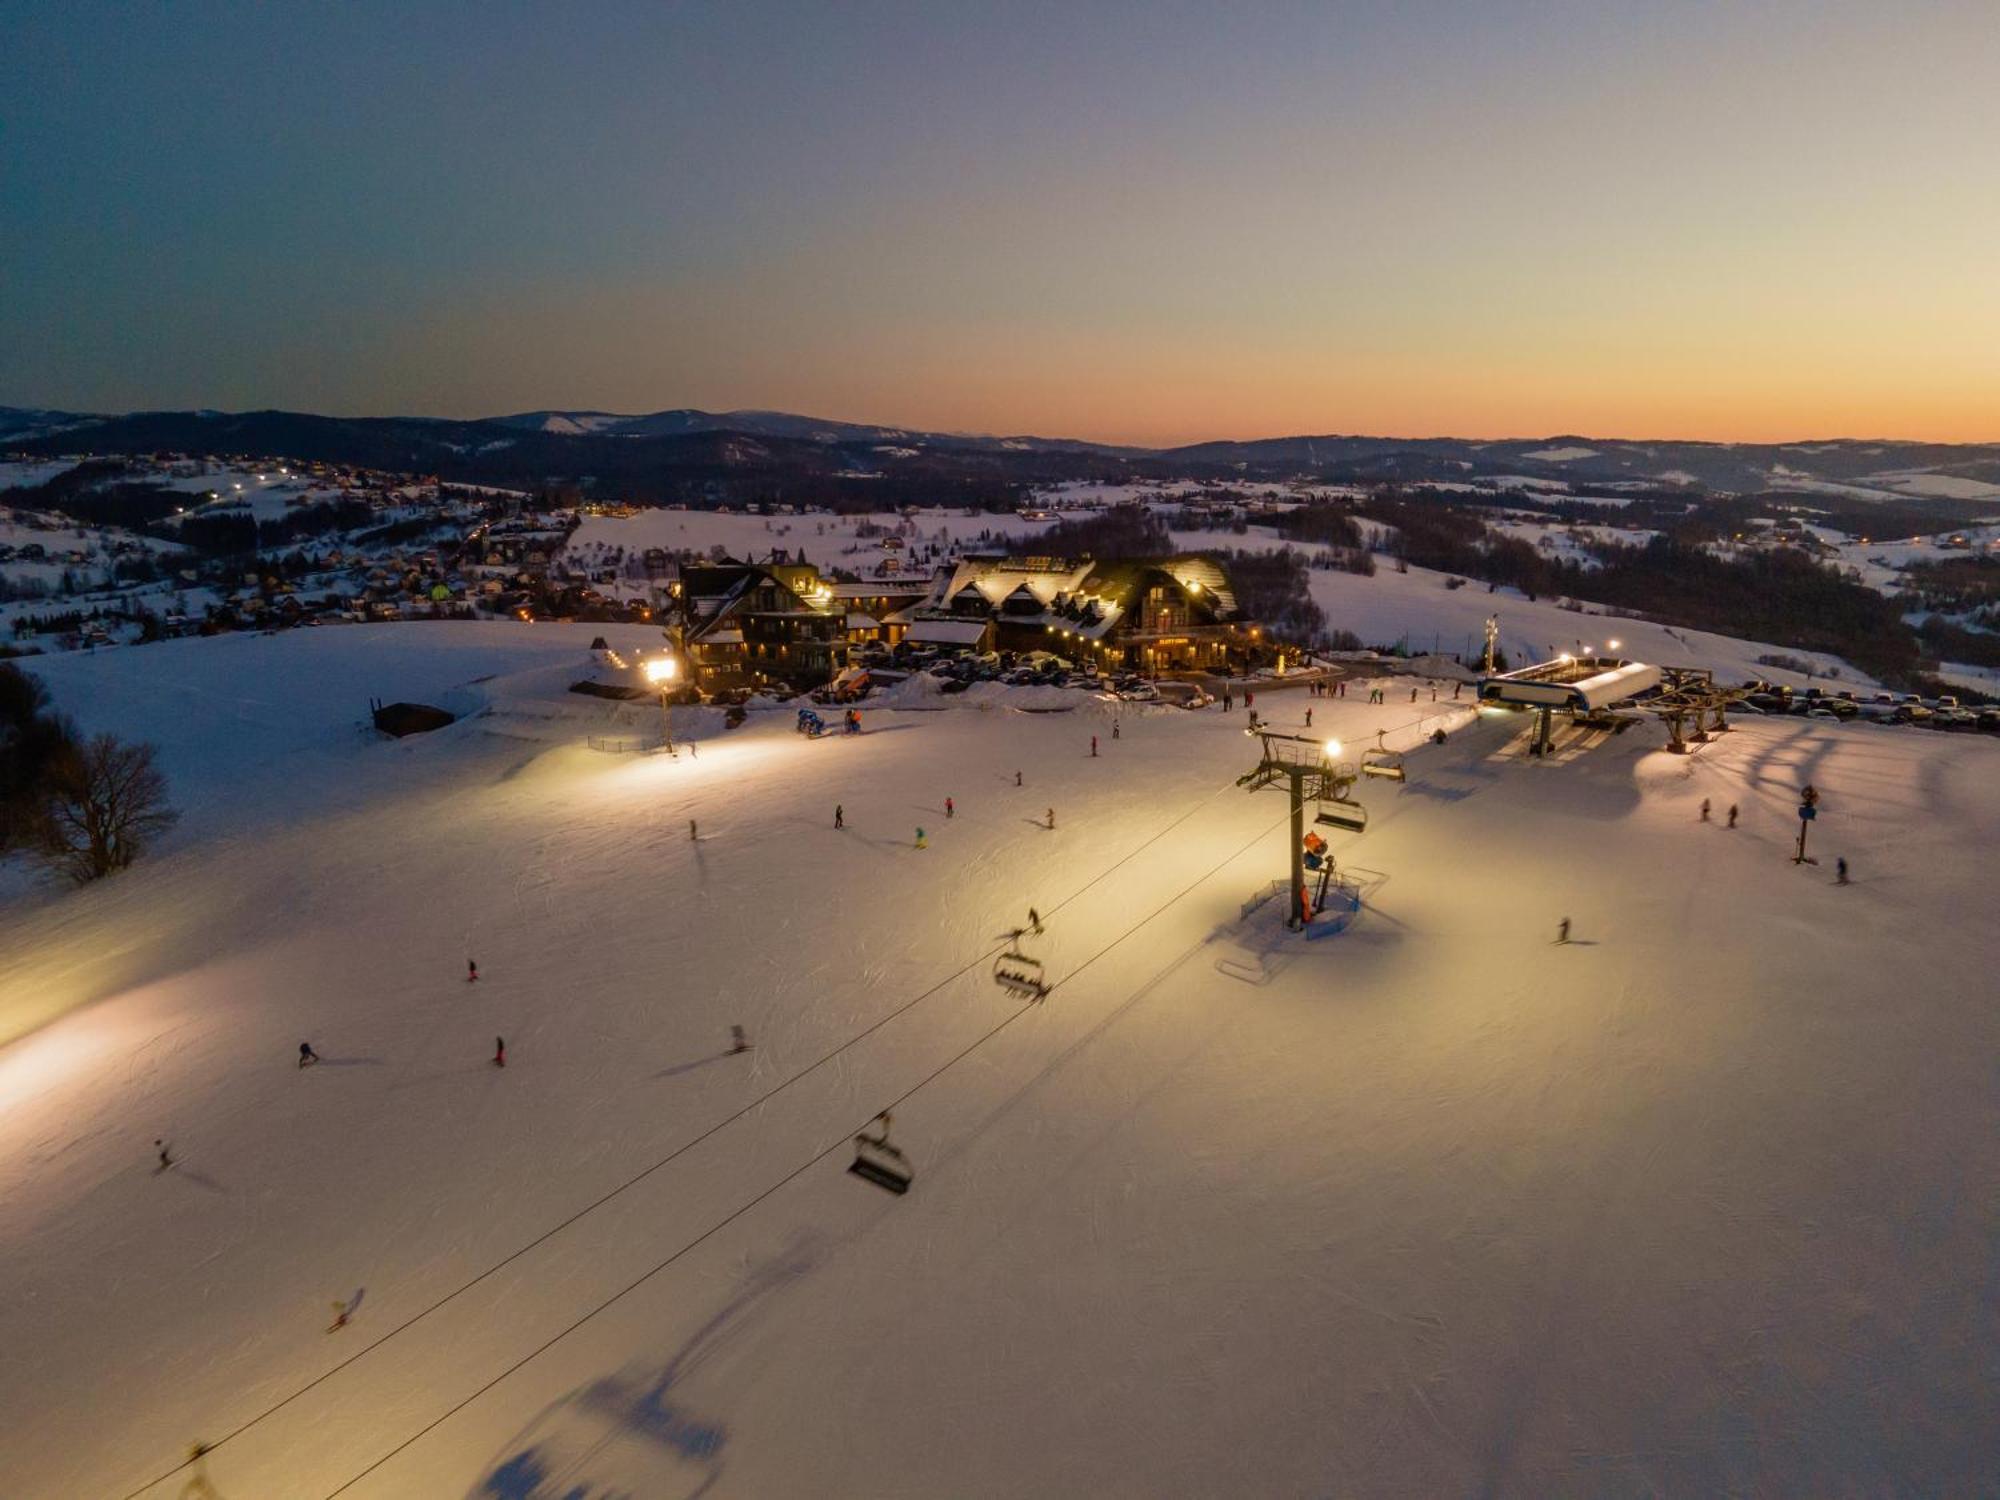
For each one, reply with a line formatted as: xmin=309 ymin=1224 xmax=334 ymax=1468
xmin=0 ymin=0 xmax=2000 ymax=444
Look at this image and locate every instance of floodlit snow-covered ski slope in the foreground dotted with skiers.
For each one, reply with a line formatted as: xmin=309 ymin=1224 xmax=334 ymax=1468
xmin=0 ymin=626 xmax=2000 ymax=1500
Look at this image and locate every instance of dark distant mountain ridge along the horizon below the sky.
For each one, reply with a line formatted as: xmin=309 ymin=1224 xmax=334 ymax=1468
xmin=0 ymin=408 xmax=2000 ymax=504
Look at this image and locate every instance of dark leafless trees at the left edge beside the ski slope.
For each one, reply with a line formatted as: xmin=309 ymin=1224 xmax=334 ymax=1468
xmin=0 ymin=662 xmax=178 ymax=884
